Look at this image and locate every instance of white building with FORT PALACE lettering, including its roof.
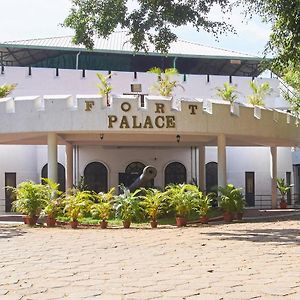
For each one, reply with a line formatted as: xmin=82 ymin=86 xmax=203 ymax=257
xmin=0 ymin=33 xmax=300 ymax=212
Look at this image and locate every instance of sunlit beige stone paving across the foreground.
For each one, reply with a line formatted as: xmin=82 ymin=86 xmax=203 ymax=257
xmin=0 ymin=218 xmax=300 ymax=300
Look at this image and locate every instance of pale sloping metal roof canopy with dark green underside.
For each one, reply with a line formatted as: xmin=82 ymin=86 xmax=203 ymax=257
xmin=0 ymin=31 xmax=262 ymax=77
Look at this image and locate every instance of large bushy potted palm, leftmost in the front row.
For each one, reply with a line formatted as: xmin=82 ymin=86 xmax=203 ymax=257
xmin=8 ymin=181 xmax=47 ymax=226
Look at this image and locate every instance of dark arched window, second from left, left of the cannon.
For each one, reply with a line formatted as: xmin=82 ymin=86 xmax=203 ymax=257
xmin=83 ymin=162 xmax=108 ymax=193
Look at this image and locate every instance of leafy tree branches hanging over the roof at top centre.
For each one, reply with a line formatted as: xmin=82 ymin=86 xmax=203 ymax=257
xmin=64 ymin=0 xmax=232 ymax=53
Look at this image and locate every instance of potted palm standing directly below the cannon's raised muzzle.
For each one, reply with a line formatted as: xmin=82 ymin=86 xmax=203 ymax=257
xmin=140 ymin=188 xmax=166 ymax=228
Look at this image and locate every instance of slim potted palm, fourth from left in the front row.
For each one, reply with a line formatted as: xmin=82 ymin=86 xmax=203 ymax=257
xmin=90 ymin=188 xmax=115 ymax=229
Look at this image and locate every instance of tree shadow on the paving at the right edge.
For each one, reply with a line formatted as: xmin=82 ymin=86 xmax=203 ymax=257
xmin=206 ymin=229 xmax=300 ymax=245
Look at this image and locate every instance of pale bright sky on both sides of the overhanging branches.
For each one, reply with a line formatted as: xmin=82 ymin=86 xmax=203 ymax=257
xmin=0 ymin=0 xmax=270 ymax=56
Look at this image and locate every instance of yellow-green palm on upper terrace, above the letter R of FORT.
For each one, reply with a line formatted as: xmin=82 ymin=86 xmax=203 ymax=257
xmin=148 ymin=67 xmax=184 ymax=97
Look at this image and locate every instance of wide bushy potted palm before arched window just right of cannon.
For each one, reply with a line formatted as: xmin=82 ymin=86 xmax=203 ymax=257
xmin=166 ymin=184 xmax=199 ymax=227
